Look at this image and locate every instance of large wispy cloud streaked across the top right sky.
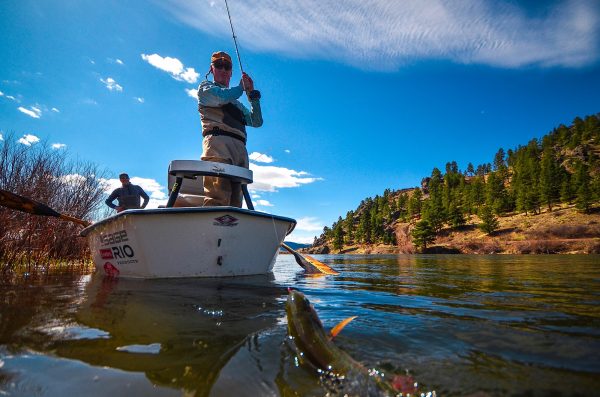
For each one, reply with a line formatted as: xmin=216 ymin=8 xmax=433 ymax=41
xmin=164 ymin=0 xmax=600 ymax=70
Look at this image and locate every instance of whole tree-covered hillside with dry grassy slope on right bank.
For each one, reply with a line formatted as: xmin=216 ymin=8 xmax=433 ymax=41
xmin=305 ymin=115 xmax=600 ymax=253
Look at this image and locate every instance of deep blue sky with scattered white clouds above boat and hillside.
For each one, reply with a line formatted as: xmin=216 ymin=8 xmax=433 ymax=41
xmin=0 ymin=0 xmax=600 ymax=242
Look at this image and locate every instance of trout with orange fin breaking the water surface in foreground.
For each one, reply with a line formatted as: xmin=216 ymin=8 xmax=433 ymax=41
xmin=286 ymin=289 xmax=428 ymax=396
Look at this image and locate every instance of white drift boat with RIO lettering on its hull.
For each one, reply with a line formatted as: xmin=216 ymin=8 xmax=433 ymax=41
xmin=81 ymin=160 xmax=296 ymax=278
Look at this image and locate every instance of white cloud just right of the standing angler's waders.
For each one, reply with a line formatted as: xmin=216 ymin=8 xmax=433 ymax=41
xmin=248 ymin=163 xmax=322 ymax=192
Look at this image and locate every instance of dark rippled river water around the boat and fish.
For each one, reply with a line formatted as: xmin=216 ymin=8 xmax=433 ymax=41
xmin=0 ymin=255 xmax=600 ymax=397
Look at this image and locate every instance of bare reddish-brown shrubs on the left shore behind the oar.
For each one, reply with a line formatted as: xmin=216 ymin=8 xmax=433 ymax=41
xmin=0 ymin=133 xmax=104 ymax=272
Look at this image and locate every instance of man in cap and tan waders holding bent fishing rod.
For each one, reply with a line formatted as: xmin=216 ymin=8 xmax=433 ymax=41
xmin=198 ymin=51 xmax=263 ymax=207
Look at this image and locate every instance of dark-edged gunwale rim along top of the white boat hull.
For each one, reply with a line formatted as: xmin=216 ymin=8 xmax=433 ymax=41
xmin=79 ymin=206 xmax=297 ymax=237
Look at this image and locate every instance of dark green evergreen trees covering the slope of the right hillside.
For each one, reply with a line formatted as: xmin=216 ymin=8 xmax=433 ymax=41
xmin=314 ymin=113 xmax=600 ymax=250
